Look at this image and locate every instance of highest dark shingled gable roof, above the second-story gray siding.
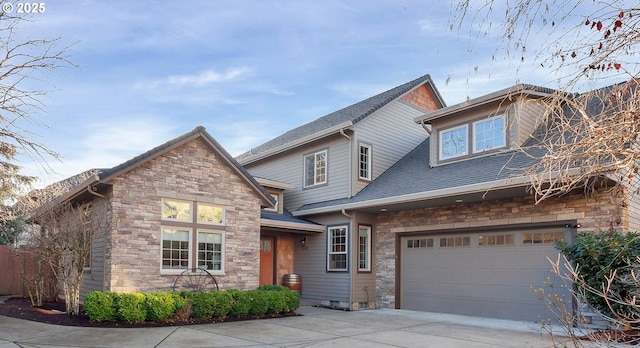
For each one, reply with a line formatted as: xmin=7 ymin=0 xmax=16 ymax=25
xmin=236 ymin=74 xmax=445 ymax=165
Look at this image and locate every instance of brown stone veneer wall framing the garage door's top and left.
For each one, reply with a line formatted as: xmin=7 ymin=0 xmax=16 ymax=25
xmin=374 ymin=192 xmax=629 ymax=308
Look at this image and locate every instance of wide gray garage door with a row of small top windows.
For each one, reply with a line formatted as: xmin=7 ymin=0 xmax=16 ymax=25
xmin=401 ymin=228 xmax=570 ymax=322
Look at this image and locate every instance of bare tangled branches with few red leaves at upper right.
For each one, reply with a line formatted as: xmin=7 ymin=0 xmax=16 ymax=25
xmin=451 ymin=0 xmax=640 ymax=202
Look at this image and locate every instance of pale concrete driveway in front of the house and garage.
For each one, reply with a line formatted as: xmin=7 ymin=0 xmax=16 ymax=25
xmin=0 ymin=306 xmax=568 ymax=348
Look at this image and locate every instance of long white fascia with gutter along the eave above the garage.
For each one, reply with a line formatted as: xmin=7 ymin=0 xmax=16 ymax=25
xmin=292 ymin=176 xmax=530 ymax=216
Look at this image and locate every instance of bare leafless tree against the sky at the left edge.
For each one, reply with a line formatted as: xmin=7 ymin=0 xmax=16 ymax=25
xmin=0 ymin=0 xmax=73 ymax=223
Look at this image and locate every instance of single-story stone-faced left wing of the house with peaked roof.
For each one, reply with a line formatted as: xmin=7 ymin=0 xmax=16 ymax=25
xmin=37 ymin=127 xmax=323 ymax=297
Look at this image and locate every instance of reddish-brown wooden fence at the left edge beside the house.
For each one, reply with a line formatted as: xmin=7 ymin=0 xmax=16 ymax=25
xmin=0 ymin=245 xmax=55 ymax=297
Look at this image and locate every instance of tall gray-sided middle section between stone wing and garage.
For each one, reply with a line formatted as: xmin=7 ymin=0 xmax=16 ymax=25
xmin=237 ymin=75 xmax=444 ymax=309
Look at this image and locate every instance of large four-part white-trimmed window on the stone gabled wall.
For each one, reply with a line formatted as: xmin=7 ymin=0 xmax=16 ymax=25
xmin=161 ymin=198 xmax=225 ymax=274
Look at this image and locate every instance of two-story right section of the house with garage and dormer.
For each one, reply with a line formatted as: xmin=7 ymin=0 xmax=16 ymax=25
xmin=238 ymin=76 xmax=638 ymax=321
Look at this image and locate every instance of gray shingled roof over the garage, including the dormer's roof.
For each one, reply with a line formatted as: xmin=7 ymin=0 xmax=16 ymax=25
xmin=293 ymin=85 xmax=624 ymax=216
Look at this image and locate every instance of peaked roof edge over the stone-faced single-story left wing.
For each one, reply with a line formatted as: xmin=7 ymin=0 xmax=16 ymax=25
xmin=41 ymin=126 xmax=275 ymax=211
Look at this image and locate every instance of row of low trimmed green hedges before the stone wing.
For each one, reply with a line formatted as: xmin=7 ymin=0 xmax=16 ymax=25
xmin=84 ymin=285 xmax=300 ymax=323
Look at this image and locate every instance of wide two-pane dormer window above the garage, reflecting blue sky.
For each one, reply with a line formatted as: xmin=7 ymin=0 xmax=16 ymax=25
xmin=438 ymin=114 xmax=507 ymax=160
